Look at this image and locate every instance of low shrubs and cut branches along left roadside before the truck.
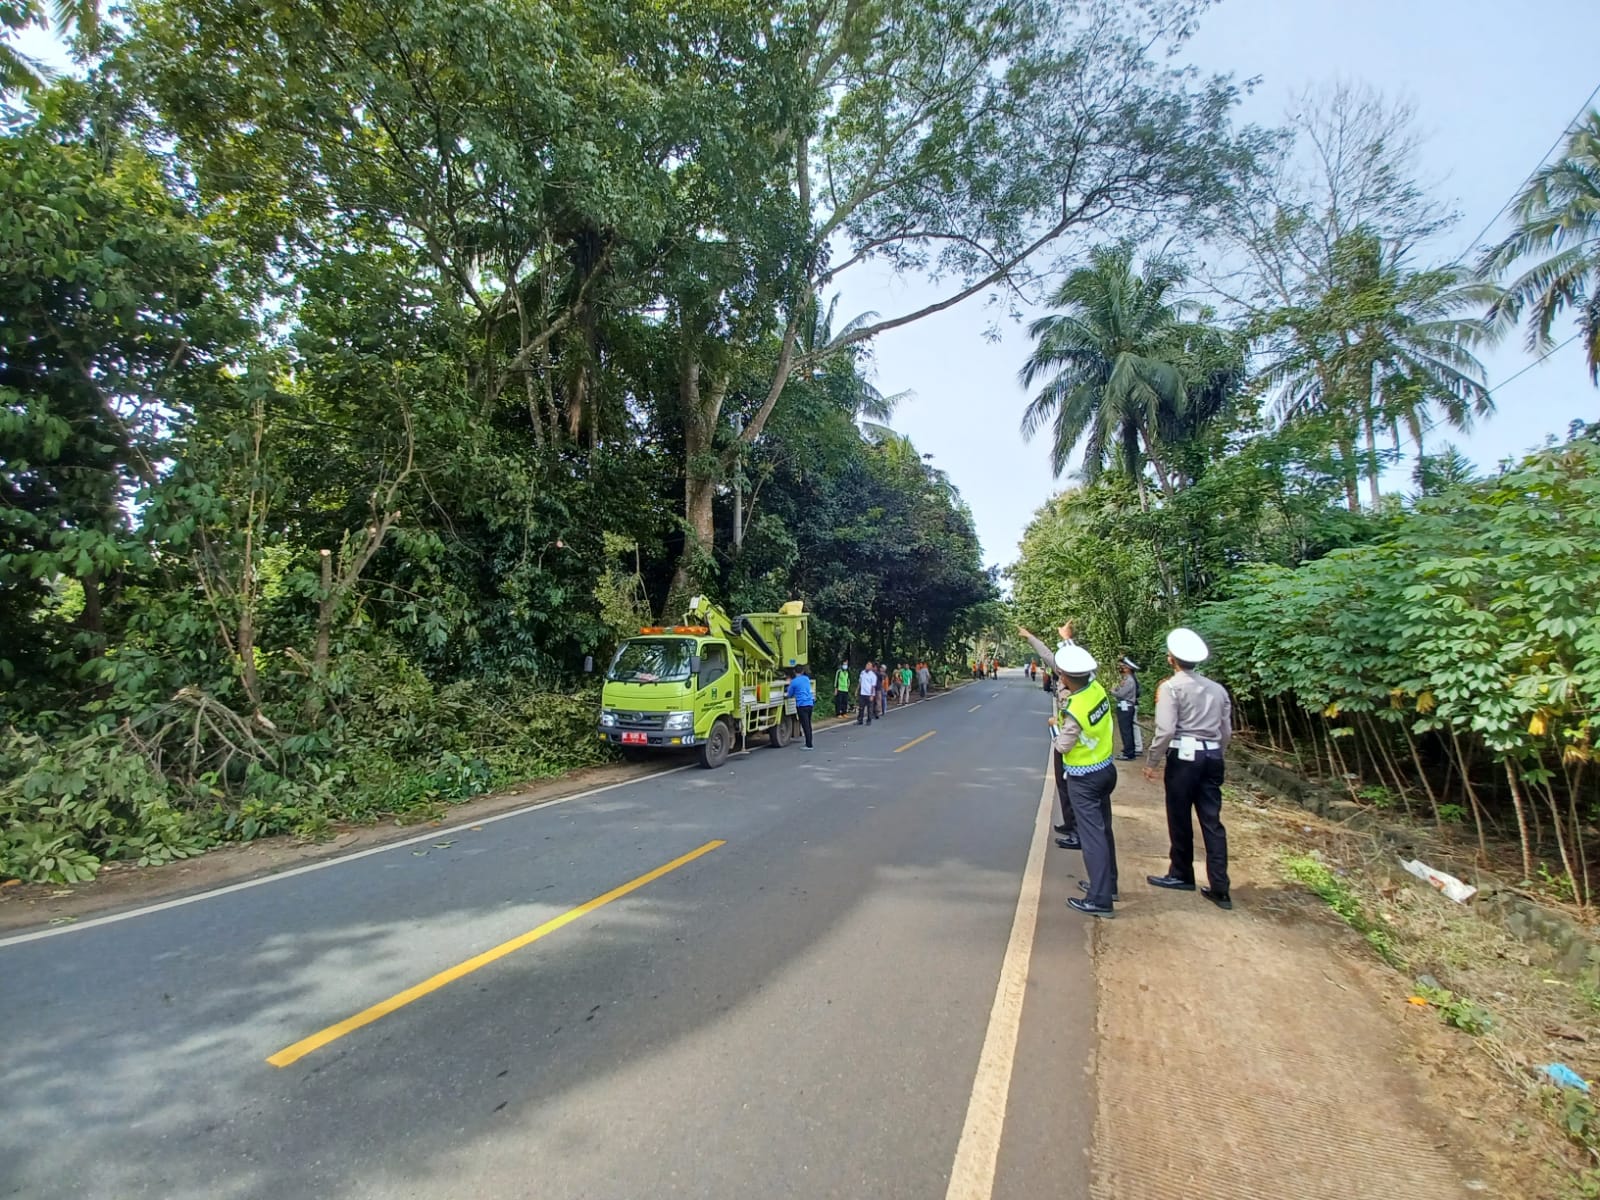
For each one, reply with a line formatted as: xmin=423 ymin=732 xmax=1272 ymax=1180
xmin=0 ymin=683 xmax=608 ymax=883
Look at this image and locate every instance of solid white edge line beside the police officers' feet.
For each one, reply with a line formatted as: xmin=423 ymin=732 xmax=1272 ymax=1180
xmin=944 ymin=761 xmax=1054 ymax=1200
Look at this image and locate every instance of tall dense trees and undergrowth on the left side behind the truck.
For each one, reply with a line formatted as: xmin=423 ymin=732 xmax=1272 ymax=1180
xmin=0 ymin=0 xmax=1267 ymax=880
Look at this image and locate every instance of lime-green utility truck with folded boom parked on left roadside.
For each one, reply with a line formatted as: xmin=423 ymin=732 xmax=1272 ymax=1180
xmin=600 ymin=595 xmax=810 ymax=768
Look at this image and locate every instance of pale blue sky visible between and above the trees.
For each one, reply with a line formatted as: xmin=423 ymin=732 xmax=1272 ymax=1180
xmin=840 ymin=0 xmax=1600 ymax=565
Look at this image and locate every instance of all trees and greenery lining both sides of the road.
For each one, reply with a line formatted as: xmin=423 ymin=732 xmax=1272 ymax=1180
xmin=0 ymin=0 xmax=1600 ymax=896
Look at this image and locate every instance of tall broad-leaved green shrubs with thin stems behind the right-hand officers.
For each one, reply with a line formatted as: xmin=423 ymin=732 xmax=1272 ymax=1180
xmin=1195 ymin=427 xmax=1600 ymax=906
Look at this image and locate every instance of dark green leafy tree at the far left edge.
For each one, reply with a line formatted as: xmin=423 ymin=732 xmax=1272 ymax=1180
xmin=0 ymin=105 xmax=250 ymax=683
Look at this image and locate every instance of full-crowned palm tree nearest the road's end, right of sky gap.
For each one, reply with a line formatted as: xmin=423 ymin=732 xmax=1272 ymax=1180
xmin=1021 ymin=245 xmax=1216 ymax=507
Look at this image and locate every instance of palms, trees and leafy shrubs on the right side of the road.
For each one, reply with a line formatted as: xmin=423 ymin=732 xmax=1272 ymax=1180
xmin=1011 ymin=88 xmax=1600 ymax=906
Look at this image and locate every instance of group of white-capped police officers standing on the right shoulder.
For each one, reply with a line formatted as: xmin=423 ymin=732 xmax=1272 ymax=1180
xmin=1018 ymin=621 xmax=1234 ymax=918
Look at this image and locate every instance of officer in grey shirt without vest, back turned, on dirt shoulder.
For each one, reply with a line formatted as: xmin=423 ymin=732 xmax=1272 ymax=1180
xmin=1144 ymin=629 xmax=1234 ymax=909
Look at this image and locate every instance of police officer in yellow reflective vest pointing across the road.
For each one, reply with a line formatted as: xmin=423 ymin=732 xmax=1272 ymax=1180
xmin=1018 ymin=621 xmax=1117 ymax=917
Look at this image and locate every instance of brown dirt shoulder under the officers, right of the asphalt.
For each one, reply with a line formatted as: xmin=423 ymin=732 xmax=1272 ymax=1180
xmin=1094 ymin=763 xmax=1504 ymax=1200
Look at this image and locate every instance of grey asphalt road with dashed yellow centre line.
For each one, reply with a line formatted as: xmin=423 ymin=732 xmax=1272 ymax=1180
xmin=0 ymin=672 xmax=1094 ymax=1200
